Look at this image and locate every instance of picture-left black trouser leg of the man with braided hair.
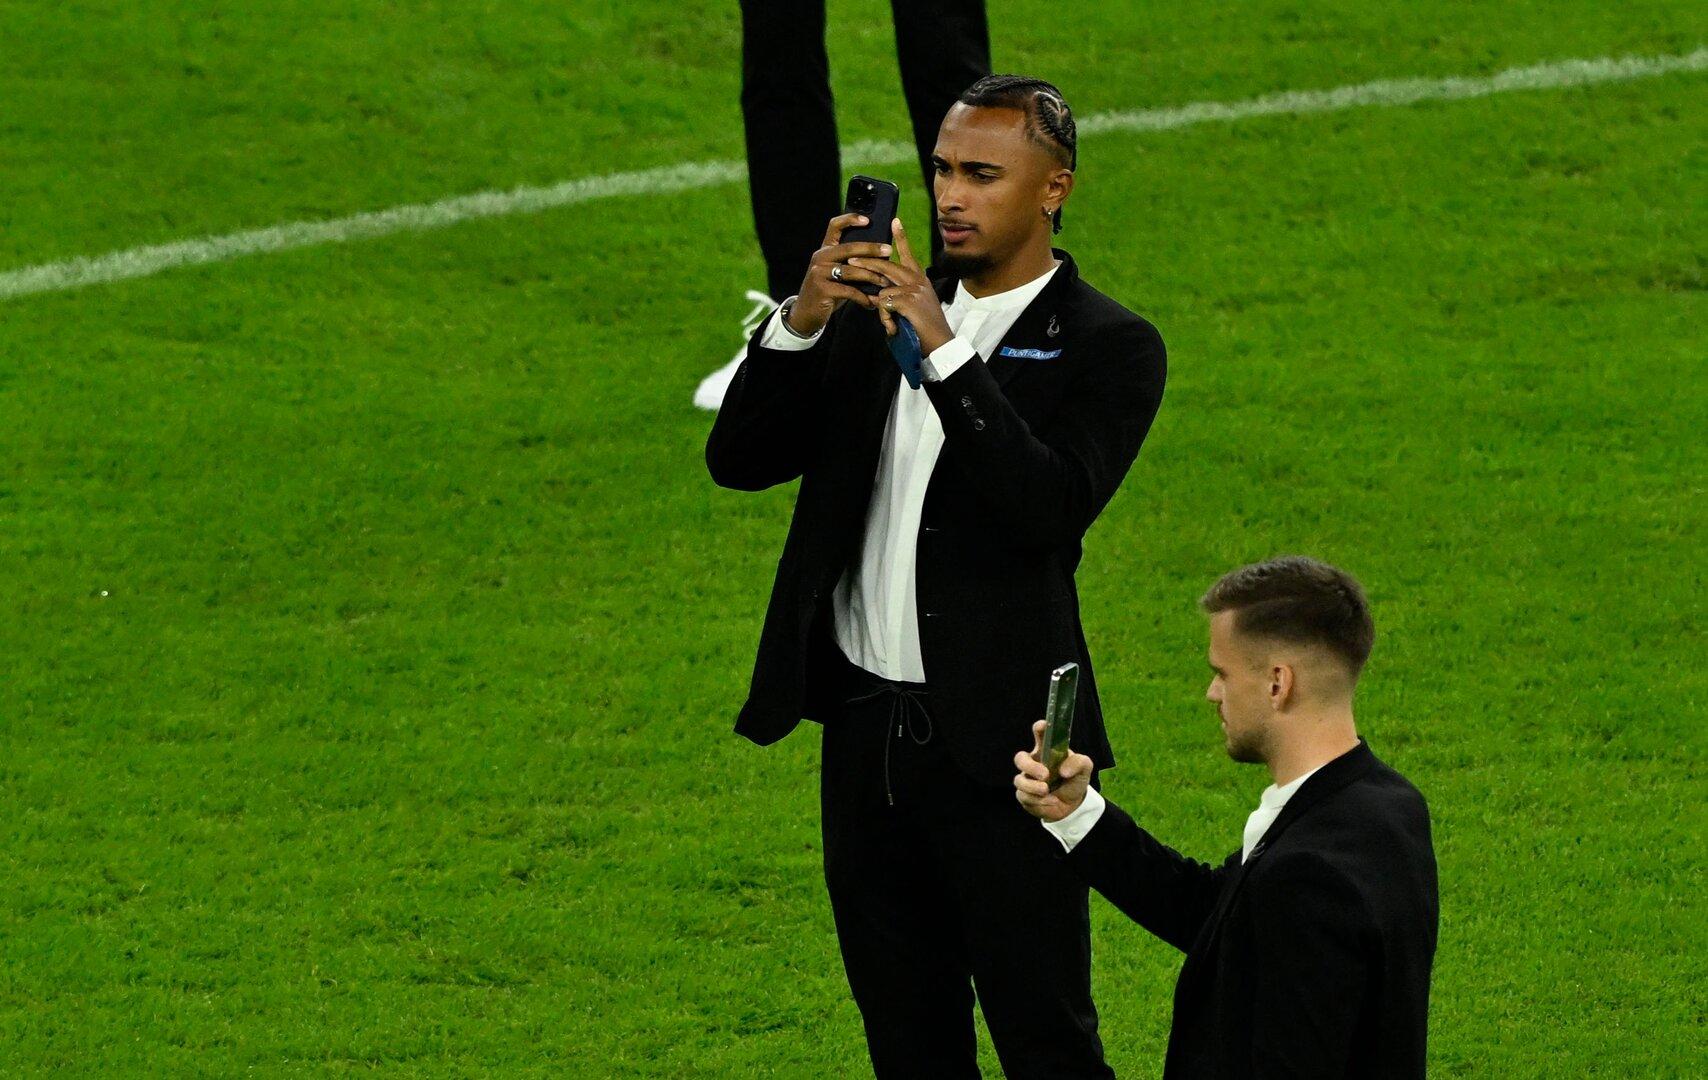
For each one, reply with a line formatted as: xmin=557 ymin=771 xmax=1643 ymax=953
xmin=822 ymin=649 xmax=983 ymax=1080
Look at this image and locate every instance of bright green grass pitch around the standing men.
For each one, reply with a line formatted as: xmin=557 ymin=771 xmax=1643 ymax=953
xmin=0 ymin=0 xmax=1708 ymax=1078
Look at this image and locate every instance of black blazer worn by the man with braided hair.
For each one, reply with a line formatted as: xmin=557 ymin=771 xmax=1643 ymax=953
xmin=705 ymin=251 xmax=1165 ymax=784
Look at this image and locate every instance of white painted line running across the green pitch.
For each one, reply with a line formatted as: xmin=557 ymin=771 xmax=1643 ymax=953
xmin=0 ymin=48 xmax=1708 ymax=301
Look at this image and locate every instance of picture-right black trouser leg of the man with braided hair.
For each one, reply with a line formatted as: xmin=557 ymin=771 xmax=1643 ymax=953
xmin=926 ymin=771 xmax=1115 ymax=1080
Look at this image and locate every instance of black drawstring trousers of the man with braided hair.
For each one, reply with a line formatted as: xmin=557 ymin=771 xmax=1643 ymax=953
xmin=822 ymin=649 xmax=1114 ymax=1080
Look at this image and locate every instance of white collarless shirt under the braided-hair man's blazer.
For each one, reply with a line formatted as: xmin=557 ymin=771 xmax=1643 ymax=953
xmin=760 ymin=263 xmax=1059 ymax=682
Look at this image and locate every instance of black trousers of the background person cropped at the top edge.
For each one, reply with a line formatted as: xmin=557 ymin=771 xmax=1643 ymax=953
xmin=741 ymin=0 xmax=991 ymax=301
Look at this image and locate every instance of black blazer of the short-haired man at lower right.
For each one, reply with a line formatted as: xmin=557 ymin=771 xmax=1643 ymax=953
xmin=1066 ymin=740 xmax=1438 ymax=1078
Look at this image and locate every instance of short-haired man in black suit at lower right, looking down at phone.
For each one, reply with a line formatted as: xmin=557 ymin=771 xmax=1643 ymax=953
xmin=1015 ymin=557 xmax=1438 ymax=1078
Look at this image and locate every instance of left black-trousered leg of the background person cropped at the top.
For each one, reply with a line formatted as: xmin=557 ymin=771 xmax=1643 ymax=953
xmin=741 ymin=0 xmax=842 ymax=301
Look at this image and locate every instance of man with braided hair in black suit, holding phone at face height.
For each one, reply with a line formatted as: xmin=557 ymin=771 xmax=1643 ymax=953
xmin=705 ymin=75 xmax=1163 ymax=1080
